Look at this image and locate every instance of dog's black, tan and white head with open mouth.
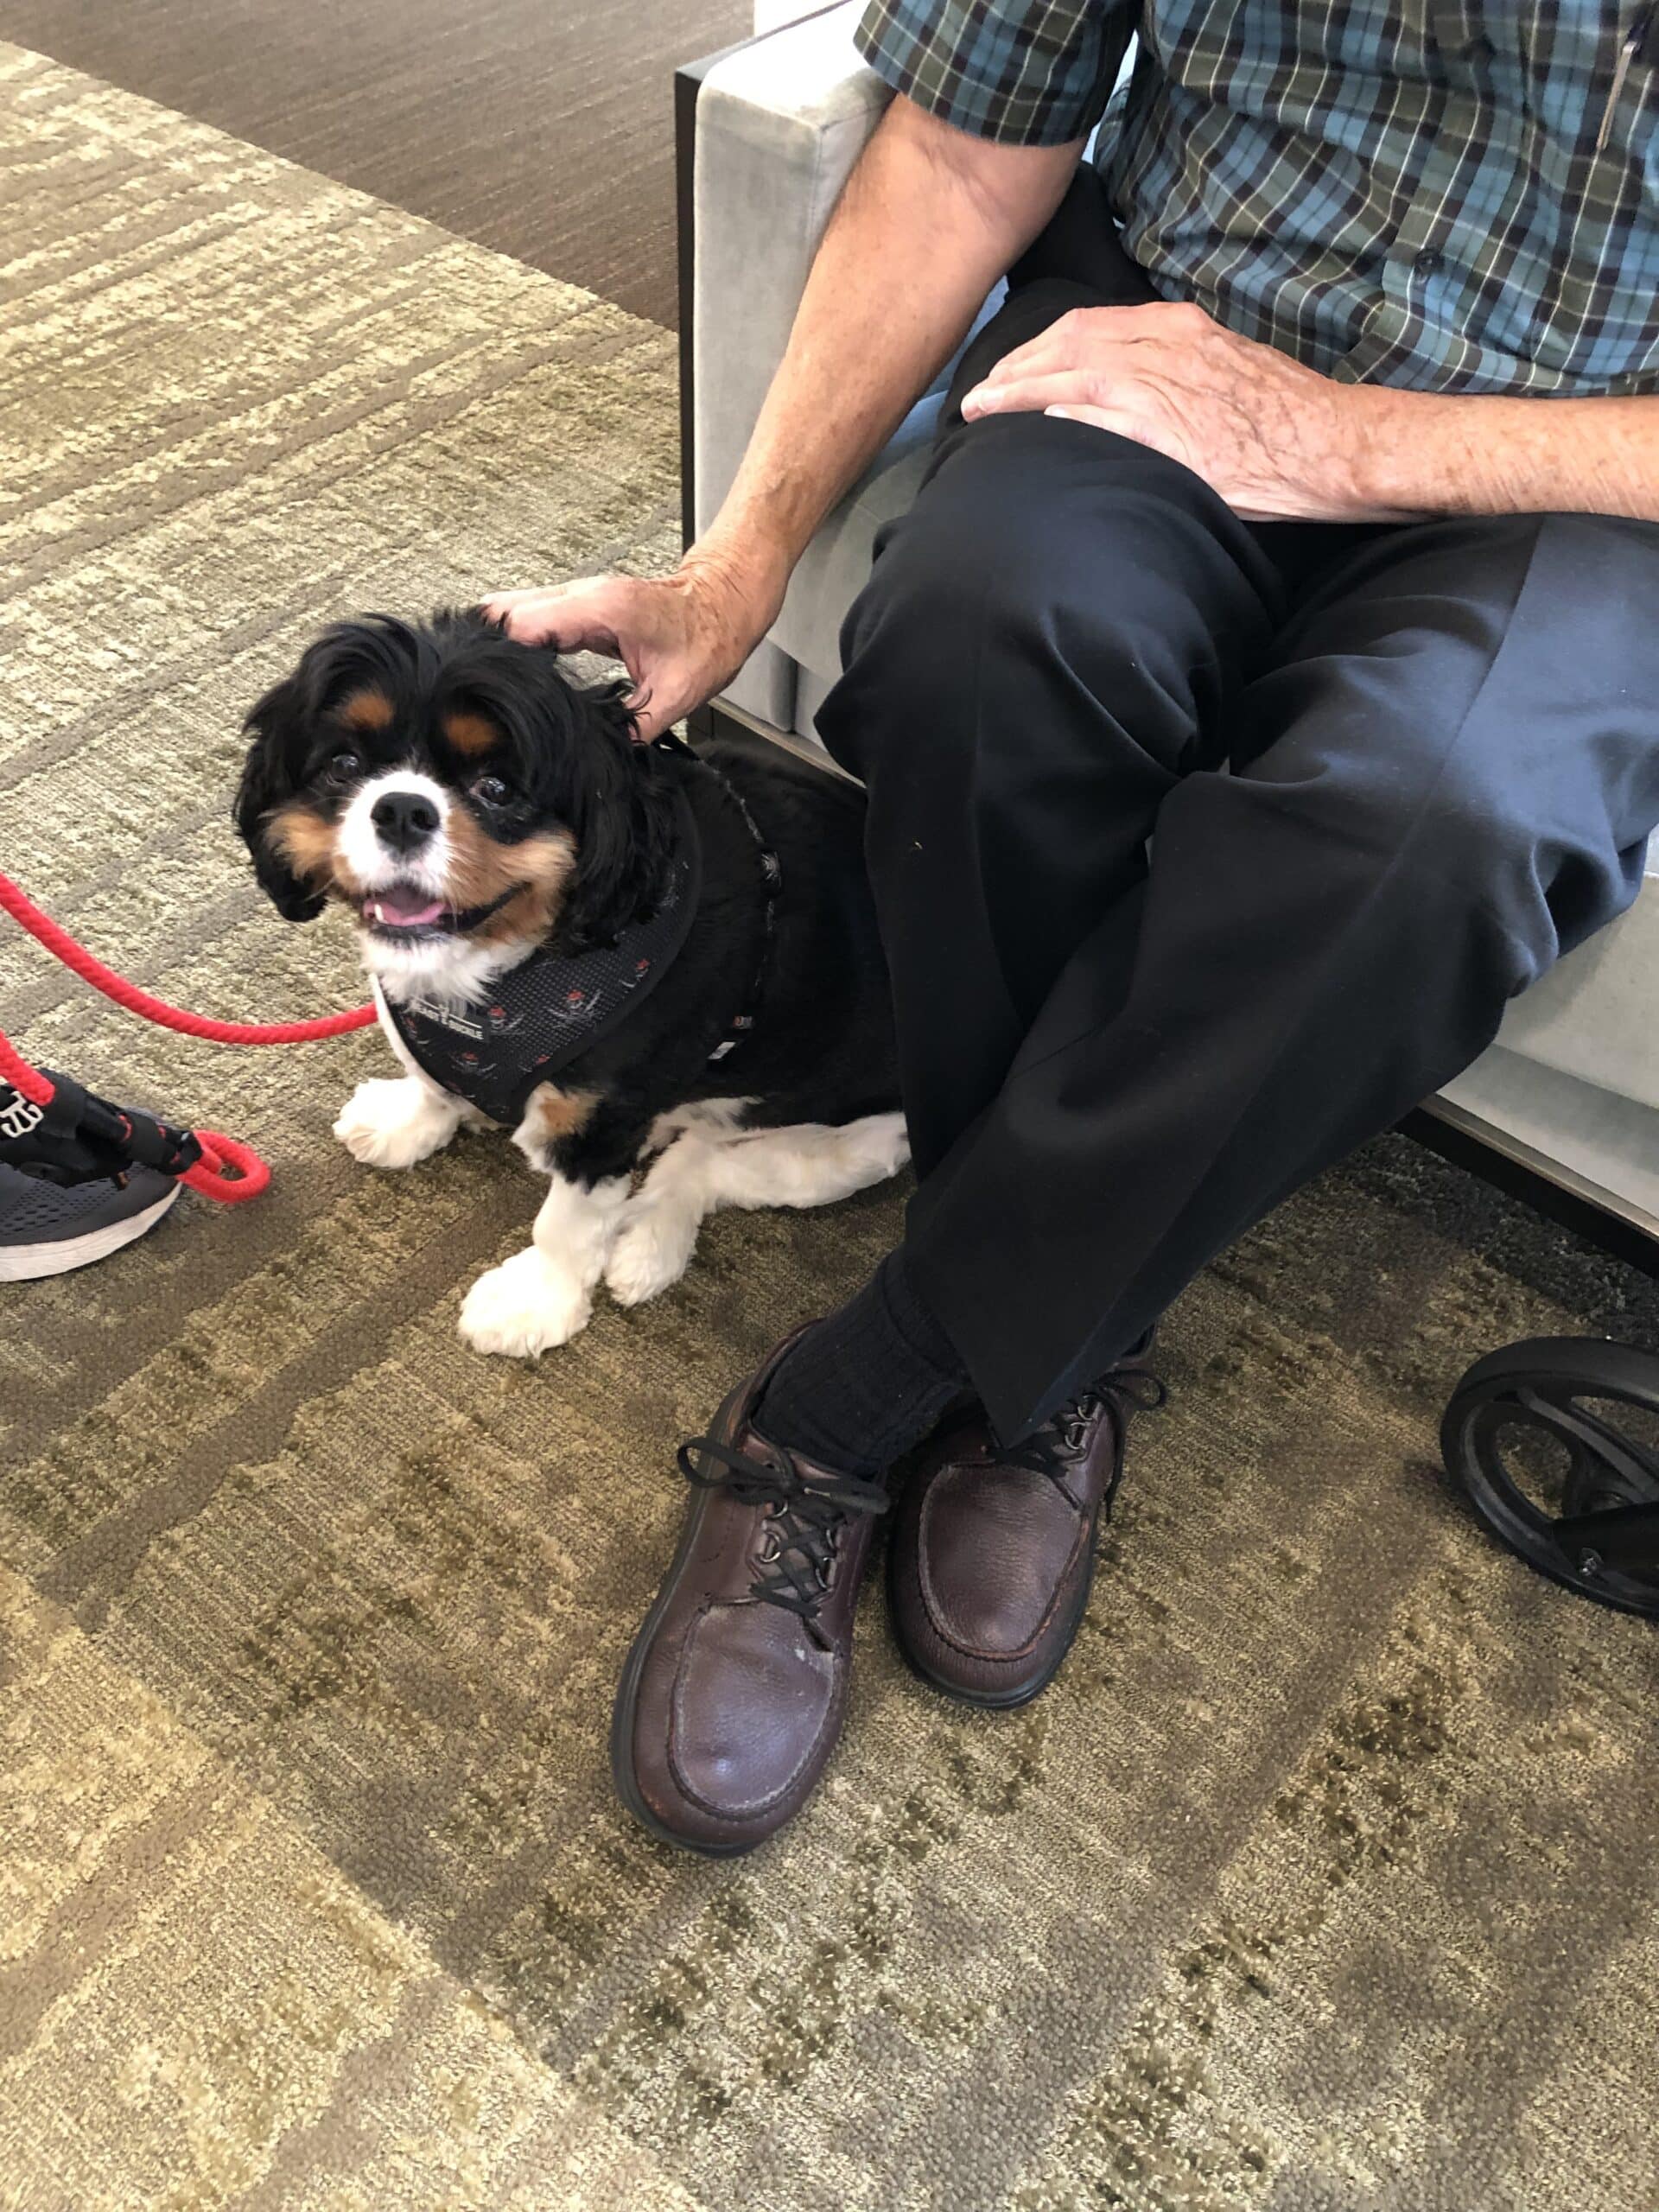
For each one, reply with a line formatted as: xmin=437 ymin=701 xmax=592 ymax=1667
xmin=234 ymin=613 xmax=672 ymax=993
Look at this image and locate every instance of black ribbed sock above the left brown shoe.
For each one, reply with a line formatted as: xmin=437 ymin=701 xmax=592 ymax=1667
xmin=757 ymin=1249 xmax=969 ymax=1478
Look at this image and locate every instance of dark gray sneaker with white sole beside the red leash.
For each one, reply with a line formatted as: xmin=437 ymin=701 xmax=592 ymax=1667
xmin=0 ymin=1075 xmax=188 ymax=1283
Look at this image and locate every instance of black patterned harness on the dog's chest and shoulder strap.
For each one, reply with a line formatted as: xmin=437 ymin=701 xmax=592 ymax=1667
xmin=380 ymin=760 xmax=783 ymax=1128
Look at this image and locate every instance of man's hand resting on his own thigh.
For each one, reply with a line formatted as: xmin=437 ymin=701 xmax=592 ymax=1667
xmin=963 ymin=303 xmax=1411 ymax=522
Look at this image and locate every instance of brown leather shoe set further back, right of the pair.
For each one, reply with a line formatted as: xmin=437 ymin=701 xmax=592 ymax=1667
xmin=887 ymin=1340 xmax=1164 ymax=1706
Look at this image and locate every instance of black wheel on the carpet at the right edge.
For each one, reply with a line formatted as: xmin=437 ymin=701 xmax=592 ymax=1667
xmin=1440 ymin=1336 xmax=1659 ymax=1619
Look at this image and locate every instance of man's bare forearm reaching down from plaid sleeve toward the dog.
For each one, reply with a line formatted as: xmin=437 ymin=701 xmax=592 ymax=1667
xmin=688 ymin=99 xmax=1079 ymax=601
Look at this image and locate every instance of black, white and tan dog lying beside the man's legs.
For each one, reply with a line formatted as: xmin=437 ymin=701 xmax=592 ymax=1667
xmin=234 ymin=611 xmax=909 ymax=1356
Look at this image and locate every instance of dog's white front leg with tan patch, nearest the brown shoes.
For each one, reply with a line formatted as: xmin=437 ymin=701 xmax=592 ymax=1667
xmin=460 ymin=1084 xmax=646 ymax=1358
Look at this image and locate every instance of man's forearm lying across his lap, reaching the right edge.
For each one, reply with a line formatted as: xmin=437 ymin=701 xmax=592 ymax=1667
xmin=1344 ymin=385 xmax=1659 ymax=522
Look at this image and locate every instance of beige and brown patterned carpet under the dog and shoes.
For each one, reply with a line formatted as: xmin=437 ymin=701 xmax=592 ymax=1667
xmin=0 ymin=47 xmax=1659 ymax=2212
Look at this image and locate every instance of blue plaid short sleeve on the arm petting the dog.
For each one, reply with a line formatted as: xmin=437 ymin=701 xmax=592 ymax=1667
xmin=854 ymin=0 xmax=1133 ymax=146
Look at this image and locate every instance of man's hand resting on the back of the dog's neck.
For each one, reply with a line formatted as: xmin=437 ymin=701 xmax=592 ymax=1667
xmin=485 ymin=556 xmax=779 ymax=743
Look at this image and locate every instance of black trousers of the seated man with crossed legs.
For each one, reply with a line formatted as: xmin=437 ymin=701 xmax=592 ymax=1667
xmin=818 ymin=181 xmax=1659 ymax=1438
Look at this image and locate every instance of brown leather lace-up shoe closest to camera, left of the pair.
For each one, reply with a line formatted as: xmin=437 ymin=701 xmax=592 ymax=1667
xmin=611 ymin=1332 xmax=887 ymax=1856
